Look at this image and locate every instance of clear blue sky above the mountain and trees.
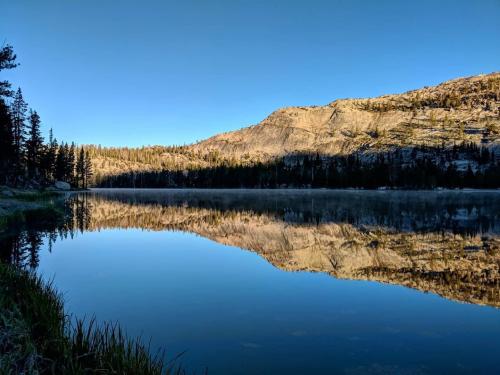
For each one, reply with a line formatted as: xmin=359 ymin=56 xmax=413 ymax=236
xmin=0 ymin=0 xmax=500 ymax=146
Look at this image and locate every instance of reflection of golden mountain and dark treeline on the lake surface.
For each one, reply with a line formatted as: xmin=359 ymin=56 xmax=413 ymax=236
xmin=69 ymin=192 xmax=500 ymax=306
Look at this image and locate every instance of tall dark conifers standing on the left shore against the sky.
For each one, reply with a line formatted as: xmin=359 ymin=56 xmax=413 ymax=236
xmin=0 ymin=45 xmax=92 ymax=188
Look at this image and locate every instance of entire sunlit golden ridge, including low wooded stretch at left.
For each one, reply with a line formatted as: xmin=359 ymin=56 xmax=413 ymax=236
xmin=87 ymin=72 xmax=500 ymax=184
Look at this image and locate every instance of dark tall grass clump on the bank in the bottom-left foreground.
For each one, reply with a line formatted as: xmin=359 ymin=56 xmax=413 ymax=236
xmin=0 ymin=263 xmax=185 ymax=375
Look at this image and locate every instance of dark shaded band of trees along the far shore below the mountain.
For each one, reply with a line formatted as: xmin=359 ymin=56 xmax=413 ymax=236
xmin=95 ymin=143 xmax=500 ymax=189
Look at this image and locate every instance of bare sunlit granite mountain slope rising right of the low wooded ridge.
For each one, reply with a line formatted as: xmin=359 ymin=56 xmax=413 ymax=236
xmin=191 ymin=73 xmax=500 ymax=159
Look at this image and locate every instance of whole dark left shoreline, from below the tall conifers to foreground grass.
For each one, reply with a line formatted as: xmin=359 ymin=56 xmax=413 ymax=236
xmin=0 ymin=186 xmax=185 ymax=375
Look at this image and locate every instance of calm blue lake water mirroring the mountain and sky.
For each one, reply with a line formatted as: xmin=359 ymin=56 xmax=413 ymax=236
xmin=3 ymin=190 xmax=500 ymax=375
